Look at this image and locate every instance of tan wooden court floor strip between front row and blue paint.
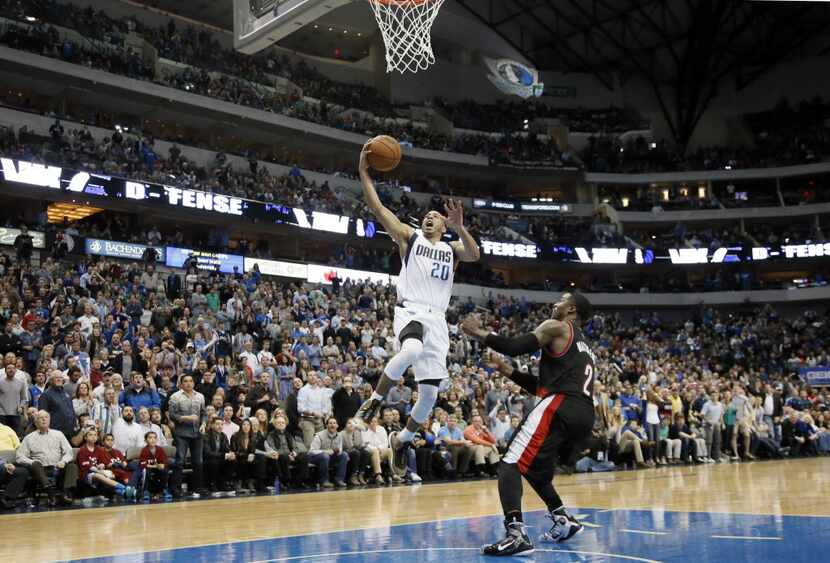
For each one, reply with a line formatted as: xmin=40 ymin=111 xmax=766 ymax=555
xmin=0 ymin=458 xmax=830 ymax=562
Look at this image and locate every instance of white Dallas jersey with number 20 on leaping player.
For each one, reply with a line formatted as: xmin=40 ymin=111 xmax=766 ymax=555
xmin=397 ymin=231 xmax=455 ymax=313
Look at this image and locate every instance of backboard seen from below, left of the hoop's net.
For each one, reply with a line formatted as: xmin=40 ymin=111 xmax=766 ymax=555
xmin=233 ymin=0 xmax=352 ymax=55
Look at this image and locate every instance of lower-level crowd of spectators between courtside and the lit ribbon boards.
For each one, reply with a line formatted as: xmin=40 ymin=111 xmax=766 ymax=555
xmin=0 ymin=242 xmax=830 ymax=509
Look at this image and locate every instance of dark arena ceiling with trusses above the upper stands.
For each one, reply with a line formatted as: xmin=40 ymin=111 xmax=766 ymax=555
xmin=135 ymin=0 xmax=830 ymax=146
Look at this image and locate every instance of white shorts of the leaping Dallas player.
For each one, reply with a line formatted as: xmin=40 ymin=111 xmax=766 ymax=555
xmin=393 ymin=304 xmax=450 ymax=381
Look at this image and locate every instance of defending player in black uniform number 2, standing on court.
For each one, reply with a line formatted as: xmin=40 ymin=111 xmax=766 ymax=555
xmin=462 ymin=293 xmax=596 ymax=556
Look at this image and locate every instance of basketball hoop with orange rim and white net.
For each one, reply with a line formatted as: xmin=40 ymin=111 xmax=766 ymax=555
xmin=369 ymin=0 xmax=444 ymax=74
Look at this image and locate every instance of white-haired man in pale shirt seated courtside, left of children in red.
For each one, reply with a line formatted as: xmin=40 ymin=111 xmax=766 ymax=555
xmin=15 ymin=410 xmax=78 ymax=505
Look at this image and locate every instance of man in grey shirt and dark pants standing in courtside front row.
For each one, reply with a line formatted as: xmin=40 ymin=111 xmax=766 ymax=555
xmin=169 ymin=374 xmax=205 ymax=498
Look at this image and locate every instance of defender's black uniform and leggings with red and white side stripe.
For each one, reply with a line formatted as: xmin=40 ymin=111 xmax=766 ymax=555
xmin=499 ymin=323 xmax=596 ymax=516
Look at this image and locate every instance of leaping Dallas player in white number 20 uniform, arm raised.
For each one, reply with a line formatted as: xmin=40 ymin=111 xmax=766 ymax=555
xmin=357 ymin=143 xmax=480 ymax=468
